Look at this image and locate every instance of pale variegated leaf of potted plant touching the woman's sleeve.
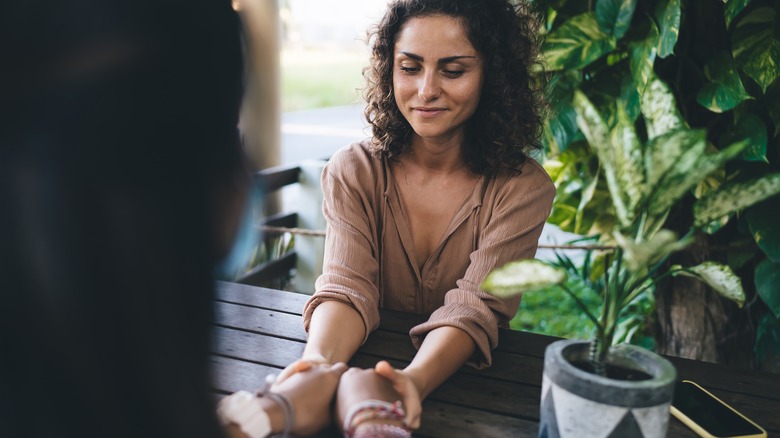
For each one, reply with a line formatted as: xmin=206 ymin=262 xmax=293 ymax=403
xmin=480 ymin=259 xmax=566 ymax=298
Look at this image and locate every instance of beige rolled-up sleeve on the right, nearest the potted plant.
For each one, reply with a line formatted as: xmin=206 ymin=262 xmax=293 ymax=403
xmin=410 ymin=169 xmax=555 ymax=368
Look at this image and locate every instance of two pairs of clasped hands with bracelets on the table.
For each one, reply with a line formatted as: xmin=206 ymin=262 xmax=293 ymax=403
xmin=218 ymin=355 xmax=422 ymax=438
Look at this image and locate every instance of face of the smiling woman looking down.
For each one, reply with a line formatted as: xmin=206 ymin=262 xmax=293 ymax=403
xmin=393 ymin=15 xmax=483 ymax=145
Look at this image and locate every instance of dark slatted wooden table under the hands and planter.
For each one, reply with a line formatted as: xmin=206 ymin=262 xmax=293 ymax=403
xmin=212 ymin=283 xmax=780 ymax=437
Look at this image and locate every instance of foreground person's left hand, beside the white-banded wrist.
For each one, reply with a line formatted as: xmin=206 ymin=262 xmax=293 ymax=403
xmin=271 ymin=361 xmax=347 ymax=435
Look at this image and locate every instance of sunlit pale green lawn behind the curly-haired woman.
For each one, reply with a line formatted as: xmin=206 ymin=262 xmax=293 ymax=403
xmin=281 ymin=49 xmax=368 ymax=111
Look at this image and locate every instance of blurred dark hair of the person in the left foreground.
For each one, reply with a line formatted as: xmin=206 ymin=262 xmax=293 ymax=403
xmin=0 ymin=0 xmax=247 ymax=438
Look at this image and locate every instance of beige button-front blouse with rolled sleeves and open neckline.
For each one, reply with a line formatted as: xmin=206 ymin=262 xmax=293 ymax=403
xmin=303 ymin=140 xmax=555 ymax=368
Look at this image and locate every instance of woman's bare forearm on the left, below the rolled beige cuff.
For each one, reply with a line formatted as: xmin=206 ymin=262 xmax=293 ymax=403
xmin=303 ymin=301 xmax=366 ymax=363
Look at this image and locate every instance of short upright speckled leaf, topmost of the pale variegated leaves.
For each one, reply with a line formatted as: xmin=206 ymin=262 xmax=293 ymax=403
xmin=640 ymin=76 xmax=685 ymax=140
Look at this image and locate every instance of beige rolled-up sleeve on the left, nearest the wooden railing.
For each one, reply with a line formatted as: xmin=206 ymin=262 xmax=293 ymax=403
xmin=303 ymin=150 xmax=379 ymax=342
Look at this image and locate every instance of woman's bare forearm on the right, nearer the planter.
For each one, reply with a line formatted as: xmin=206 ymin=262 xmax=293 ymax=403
xmin=404 ymin=326 xmax=476 ymax=399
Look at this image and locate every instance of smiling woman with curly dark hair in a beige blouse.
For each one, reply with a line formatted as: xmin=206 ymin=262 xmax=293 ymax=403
xmin=282 ymin=0 xmax=555 ymax=436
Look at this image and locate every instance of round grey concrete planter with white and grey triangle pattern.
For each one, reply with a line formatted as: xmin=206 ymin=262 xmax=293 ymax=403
xmin=539 ymin=339 xmax=677 ymax=438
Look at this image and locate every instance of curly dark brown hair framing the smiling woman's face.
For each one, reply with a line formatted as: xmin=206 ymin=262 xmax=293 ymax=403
xmin=363 ymin=0 xmax=544 ymax=176
